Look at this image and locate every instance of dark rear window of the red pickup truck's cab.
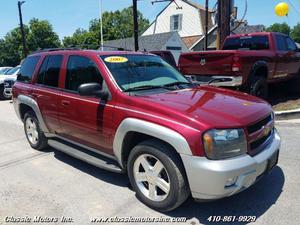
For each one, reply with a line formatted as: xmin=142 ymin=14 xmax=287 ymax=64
xmin=223 ymin=36 xmax=269 ymax=50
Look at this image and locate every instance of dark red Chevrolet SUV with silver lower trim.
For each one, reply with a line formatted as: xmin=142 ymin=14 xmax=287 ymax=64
xmin=13 ymin=49 xmax=280 ymax=211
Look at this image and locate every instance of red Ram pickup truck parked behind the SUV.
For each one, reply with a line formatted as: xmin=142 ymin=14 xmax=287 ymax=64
xmin=179 ymin=32 xmax=300 ymax=98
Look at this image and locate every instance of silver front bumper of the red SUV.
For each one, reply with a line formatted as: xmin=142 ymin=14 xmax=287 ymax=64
xmin=181 ymin=131 xmax=281 ymax=200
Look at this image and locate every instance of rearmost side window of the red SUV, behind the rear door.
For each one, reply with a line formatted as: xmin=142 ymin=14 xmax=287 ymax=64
xmin=17 ymin=56 xmax=41 ymax=83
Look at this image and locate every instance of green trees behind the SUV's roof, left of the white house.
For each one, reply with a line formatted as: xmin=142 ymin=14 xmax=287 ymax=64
xmin=63 ymin=7 xmax=149 ymax=48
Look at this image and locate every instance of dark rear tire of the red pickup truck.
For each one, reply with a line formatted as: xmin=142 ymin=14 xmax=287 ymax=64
xmin=249 ymin=76 xmax=269 ymax=99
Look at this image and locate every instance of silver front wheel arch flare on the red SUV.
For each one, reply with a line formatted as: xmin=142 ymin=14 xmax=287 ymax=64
xmin=113 ymin=118 xmax=192 ymax=168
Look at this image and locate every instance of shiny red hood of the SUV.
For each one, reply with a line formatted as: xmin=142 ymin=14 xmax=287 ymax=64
xmin=138 ymin=86 xmax=272 ymax=130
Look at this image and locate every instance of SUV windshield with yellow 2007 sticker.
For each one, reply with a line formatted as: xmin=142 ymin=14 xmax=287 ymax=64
xmin=100 ymin=55 xmax=190 ymax=91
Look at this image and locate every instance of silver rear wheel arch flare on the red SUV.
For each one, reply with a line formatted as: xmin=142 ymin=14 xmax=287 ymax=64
xmin=14 ymin=95 xmax=49 ymax=133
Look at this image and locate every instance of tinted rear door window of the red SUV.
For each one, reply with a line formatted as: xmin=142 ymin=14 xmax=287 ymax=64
xmin=37 ymin=55 xmax=63 ymax=87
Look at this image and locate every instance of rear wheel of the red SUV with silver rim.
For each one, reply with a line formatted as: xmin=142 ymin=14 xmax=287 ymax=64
xmin=24 ymin=111 xmax=48 ymax=151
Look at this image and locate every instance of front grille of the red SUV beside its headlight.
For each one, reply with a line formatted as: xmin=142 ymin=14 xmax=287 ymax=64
xmin=247 ymin=114 xmax=274 ymax=156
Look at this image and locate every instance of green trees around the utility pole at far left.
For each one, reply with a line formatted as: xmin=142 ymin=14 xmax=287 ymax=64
xmin=0 ymin=19 xmax=60 ymax=66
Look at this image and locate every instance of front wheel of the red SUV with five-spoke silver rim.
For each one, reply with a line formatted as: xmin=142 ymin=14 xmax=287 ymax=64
xmin=127 ymin=140 xmax=190 ymax=212
